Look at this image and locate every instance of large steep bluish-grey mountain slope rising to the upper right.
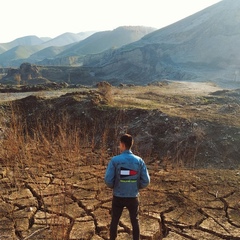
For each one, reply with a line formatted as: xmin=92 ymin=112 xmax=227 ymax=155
xmin=83 ymin=0 xmax=240 ymax=86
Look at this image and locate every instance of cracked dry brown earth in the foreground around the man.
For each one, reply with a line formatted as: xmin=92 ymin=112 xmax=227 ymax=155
xmin=0 ymin=152 xmax=240 ymax=240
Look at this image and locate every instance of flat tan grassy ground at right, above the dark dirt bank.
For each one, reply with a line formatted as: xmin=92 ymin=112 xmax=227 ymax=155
xmin=113 ymin=82 xmax=240 ymax=126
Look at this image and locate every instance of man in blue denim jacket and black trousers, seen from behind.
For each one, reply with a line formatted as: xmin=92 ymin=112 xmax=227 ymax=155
xmin=105 ymin=134 xmax=150 ymax=240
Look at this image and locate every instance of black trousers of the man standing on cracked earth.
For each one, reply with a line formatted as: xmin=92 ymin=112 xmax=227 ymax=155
xmin=110 ymin=196 xmax=140 ymax=240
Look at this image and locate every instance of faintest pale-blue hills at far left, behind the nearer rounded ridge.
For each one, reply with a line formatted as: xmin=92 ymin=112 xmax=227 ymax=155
xmin=0 ymin=32 xmax=94 ymax=67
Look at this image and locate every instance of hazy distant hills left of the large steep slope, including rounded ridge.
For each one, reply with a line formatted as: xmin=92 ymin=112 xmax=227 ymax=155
xmin=0 ymin=26 xmax=156 ymax=67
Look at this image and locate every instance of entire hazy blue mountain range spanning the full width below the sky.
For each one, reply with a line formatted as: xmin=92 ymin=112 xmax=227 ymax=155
xmin=0 ymin=0 xmax=240 ymax=85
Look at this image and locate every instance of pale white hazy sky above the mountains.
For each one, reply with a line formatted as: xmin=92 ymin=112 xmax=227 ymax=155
xmin=0 ymin=0 xmax=220 ymax=43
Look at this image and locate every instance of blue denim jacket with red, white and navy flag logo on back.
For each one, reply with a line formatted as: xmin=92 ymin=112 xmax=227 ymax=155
xmin=105 ymin=150 xmax=150 ymax=197
